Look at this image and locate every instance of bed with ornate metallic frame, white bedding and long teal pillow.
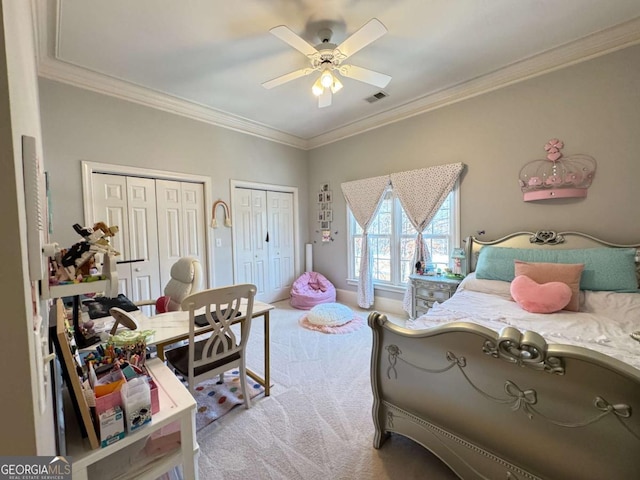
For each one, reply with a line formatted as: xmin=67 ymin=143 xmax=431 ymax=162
xmin=368 ymin=231 xmax=640 ymax=480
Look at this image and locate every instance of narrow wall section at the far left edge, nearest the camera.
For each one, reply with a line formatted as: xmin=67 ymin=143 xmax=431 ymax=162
xmin=0 ymin=1 xmax=55 ymax=455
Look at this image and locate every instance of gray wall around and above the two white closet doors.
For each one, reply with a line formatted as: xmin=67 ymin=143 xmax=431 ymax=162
xmin=40 ymin=79 xmax=309 ymax=285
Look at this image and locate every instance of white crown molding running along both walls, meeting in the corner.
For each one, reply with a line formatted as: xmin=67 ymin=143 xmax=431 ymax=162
xmin=32 ymin=0 xmax=640 ymax=150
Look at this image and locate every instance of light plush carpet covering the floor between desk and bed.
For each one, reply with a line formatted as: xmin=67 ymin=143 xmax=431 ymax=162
xmin=197 ymin=301 xmax=457 ymax=480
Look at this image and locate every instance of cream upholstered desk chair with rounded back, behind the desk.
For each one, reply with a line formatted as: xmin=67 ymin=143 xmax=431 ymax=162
xmin=134 ymin=257 xmax=202 ymax=313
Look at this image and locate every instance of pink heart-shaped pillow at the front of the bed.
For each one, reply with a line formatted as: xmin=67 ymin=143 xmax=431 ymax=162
xmin=511 ymin=275 xmax=572 ymax=313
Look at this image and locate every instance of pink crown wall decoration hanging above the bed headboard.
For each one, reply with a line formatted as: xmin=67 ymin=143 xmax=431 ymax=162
xmin=520 ymin=138 xmax=596 ymax=202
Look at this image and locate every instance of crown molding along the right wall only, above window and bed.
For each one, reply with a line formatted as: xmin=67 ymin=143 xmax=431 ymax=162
xmin=308 ymin=17 xmax=640 ymax=150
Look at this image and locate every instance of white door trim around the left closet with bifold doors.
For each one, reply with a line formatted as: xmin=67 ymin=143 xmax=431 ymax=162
xmin=81 ymin=160 xmax=215 ymax=287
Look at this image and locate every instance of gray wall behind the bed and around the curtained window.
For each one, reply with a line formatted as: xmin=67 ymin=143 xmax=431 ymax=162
xmin=309 ymin=46 xmax=640 ymax=297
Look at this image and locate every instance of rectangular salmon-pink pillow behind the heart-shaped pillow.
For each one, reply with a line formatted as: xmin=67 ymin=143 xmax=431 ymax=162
xmin=512 ymin=260 xmax=584 ymax=312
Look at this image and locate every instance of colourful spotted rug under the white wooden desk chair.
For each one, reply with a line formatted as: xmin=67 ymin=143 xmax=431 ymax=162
xmin=194 ymin=370 xmax=264 ymax=431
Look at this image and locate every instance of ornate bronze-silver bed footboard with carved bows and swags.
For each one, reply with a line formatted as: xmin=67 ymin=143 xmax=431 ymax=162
xmin=368 ymin=312 xmax=640 ymax=480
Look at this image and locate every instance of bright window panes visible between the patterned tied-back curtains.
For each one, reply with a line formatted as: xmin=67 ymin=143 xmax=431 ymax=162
xmin=347 ymin=185 xmax=459 ymax=287
